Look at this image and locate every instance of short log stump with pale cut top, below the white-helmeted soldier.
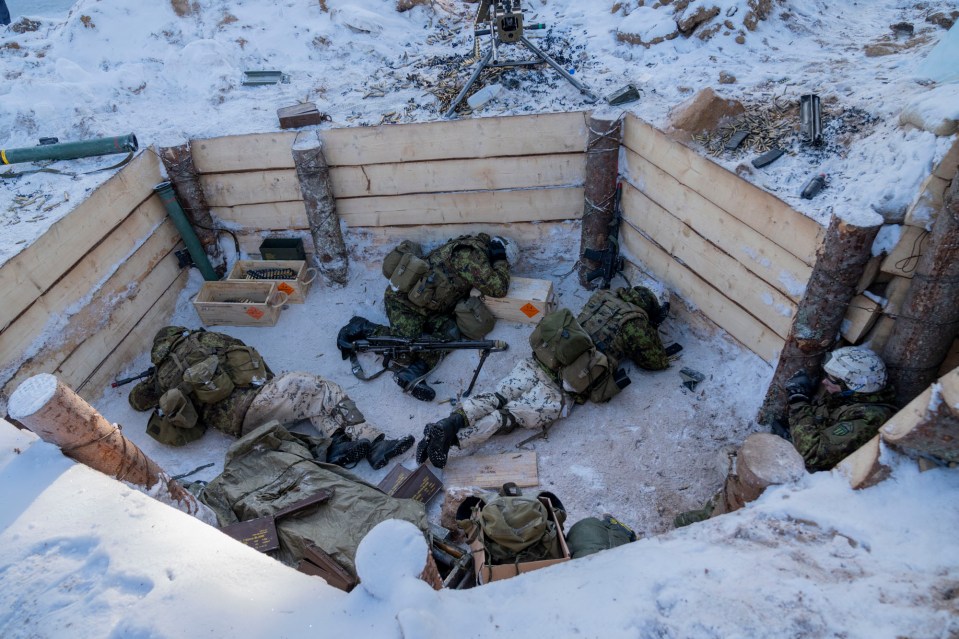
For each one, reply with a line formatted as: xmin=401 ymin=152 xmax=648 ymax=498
xmin=710 ymin=433 xmax=806 ymax=517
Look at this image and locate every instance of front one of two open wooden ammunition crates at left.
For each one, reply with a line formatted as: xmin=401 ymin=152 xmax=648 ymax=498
xmin=193 ymin=280 xmax=287 ymax=326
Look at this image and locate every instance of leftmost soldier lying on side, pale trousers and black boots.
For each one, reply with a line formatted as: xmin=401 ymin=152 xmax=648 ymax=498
xmin=129 ymin=326 xmax=413 ymax=468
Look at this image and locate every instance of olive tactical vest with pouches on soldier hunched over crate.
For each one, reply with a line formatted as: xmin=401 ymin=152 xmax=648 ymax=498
xmin=383 ymin=233 xmax=489 ymax=314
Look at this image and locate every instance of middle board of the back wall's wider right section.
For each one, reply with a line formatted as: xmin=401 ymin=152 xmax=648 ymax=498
xmin=330 ymin=153 xmax=586 ymax=199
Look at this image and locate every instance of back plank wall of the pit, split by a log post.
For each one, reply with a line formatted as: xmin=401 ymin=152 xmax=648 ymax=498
xmin=191 ymin=112 xmax=587 ymax=254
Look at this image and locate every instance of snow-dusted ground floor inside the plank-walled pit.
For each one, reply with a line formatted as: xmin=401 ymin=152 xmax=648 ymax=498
xmin=97 ymin=225 xmax=772 ymax=536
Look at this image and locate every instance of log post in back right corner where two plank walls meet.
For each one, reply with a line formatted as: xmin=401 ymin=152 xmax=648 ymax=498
xmin=579 ymin=115 xmax=622 ymax=289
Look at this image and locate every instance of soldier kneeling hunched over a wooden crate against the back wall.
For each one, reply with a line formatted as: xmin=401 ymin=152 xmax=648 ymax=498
xmin=337 ymin=233 xmax=518 ymax=401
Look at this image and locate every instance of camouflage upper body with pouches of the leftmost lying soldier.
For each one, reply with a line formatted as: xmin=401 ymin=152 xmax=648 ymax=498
xmin=129 ymin=326 xmax=273 ymax=446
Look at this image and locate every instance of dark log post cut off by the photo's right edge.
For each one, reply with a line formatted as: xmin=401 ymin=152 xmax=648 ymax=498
xmin=882 ymin=173 xmax=959 ymax=406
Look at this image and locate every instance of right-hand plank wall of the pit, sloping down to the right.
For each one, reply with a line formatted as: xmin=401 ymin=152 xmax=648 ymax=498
xmin=620 ymin=116 xmax=824 ymax=362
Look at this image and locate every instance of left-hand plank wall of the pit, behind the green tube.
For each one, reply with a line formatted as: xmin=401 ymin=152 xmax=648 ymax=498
xmin=0 ymin=151 xmax=186 ymax=412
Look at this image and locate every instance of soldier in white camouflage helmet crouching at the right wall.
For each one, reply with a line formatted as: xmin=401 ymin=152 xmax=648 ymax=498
xmin=785 ymin=346 xmax=896 ymax=472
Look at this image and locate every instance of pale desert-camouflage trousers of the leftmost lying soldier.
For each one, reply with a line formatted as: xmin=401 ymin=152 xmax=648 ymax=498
xmin=242 ymin=372 xmax=383 ymax=441
